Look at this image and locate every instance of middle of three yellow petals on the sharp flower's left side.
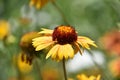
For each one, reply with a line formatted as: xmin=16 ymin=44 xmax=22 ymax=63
xmin=32 ymin=36 xmax=52 ymax=47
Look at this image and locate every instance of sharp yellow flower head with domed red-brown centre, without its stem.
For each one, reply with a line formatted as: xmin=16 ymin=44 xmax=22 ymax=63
xmin=33 ymin=26 xmax=96 ymax=61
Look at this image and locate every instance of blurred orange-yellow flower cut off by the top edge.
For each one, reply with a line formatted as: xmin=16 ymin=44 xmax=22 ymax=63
xmin=29 ymin=0 xmax=52 ymax=9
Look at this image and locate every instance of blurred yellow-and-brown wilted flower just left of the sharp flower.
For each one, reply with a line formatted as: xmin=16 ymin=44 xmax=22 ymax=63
xmin=20 ymin=31 xmax=40 ymax=64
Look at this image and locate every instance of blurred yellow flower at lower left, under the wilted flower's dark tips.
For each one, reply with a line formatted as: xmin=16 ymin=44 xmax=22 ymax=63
xmin=17 ymin=53 xmax=33 ymax=73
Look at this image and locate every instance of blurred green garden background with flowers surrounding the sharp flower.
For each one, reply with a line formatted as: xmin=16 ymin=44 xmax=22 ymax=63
xmin=0 ymin=0 xmax=120 ymax=80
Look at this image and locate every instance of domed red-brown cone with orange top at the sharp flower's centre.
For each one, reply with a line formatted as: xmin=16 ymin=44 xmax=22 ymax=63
xmin=52 ymin=26 xmax=77 ymax=45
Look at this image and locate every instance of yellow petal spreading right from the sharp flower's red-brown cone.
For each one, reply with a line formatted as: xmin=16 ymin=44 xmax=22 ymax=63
xmin=77 ymin=36 xmax=97 ymax=49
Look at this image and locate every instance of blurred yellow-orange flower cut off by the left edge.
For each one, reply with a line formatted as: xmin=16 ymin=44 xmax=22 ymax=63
xmin=0 ymin=20 xmax=9 ymax=40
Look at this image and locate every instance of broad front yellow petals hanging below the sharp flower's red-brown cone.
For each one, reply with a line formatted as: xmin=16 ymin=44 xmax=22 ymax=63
xmin=46 ymin=44 xmax=74 ymax=61
